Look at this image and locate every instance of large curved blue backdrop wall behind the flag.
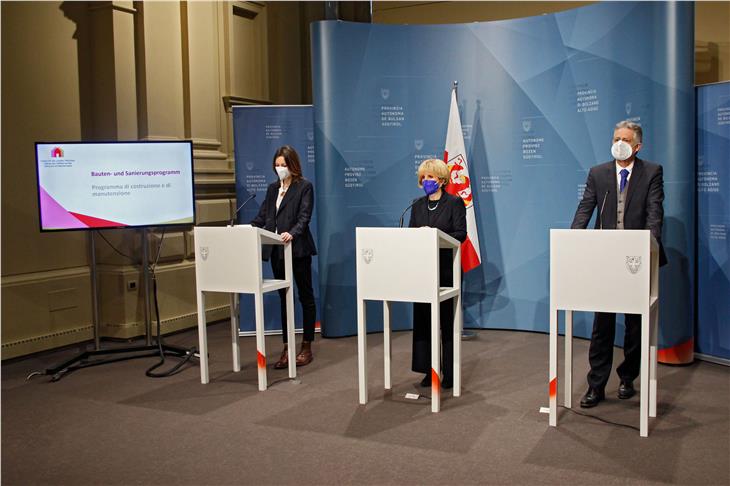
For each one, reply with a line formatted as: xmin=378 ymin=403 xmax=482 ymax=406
xmin=312 ymin=2 xmax=694 ymax=358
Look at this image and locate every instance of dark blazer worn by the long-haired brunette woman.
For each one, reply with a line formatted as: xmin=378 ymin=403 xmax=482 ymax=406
xmin=251 ymin=179 xmax=317 ymax=259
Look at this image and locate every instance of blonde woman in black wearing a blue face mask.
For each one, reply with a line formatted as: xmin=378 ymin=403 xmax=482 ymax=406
xmin=408 ymin=159 xmax=466 ymax=388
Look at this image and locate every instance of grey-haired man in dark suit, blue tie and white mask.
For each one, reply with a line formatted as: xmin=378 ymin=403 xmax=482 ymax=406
xmin=570 ymin=121 xmax=667 ymax=408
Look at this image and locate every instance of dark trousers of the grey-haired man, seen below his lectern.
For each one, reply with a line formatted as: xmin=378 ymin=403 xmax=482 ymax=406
xmin=588 ymin=312 xmax=641 ymax=390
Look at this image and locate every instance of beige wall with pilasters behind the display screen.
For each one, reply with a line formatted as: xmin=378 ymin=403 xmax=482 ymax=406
xmin=0 ymin=1 xmax=282 ymax=359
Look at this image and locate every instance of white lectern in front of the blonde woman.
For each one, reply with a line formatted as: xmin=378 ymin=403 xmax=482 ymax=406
xmin=355 ymin=228 xmax=462 ymax=412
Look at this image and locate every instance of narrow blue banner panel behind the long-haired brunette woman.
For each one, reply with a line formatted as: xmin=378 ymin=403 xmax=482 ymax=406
xmin=233 ymin=105 xmax=319 ymax=332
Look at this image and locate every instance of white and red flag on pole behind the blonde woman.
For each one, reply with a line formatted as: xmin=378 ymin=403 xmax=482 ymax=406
xmin=444 ymin=88 xmax=482 ymax=272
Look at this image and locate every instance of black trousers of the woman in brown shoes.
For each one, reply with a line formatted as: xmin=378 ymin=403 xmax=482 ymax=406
xmin=271 ymin=246 xmax=317 ymax=344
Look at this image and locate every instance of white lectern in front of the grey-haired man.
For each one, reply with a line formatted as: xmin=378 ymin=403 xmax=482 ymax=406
xmin=549 ymin=229 xmax=659 ymax=437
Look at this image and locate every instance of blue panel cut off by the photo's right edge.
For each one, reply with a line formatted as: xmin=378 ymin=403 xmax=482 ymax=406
xmin=696 ymin=83 xmax=730 ymax=359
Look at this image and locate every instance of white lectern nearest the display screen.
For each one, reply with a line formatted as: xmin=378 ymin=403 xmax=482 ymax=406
xmin=194 ymin=225 xmax=296 ymax=390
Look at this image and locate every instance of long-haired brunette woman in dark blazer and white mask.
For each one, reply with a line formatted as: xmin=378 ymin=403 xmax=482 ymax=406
xmin=251 ymin=145 xmax=317 ymax=369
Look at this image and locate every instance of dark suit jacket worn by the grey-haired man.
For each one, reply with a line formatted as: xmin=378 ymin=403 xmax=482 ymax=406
xmin=570 ymin=157 xmax=667 ymax=265
